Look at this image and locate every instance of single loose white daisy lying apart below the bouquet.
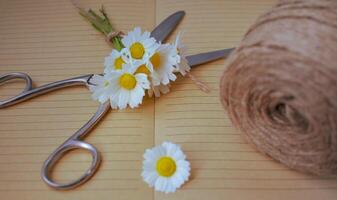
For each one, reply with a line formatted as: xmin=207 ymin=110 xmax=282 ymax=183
xmin=142 ymin=142 xmax=190 ymax=193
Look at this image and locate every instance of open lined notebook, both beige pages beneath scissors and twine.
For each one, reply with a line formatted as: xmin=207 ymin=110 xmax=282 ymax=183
xmin=0 ymin=0 xmax=337 ymax=200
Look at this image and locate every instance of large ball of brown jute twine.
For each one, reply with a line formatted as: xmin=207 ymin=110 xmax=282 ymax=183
xmin=220 ymin=0 xmax=337 ymax=175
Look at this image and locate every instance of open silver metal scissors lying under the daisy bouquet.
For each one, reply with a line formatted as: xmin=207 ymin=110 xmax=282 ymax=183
xmin=0 ymin=11 xmax=233 ymax=190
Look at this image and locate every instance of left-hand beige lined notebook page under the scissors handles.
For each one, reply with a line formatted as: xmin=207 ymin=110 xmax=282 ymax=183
xmin=0 ymin=0 xmax=155 ymax=200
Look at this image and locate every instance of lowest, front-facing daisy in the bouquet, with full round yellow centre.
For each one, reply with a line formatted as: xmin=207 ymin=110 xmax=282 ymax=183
xmin=110 ymin=63 xmax=150 ymax=109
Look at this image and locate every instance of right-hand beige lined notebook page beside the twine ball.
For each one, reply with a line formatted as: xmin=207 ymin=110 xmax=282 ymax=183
xmin=155 ymin=0 xmax=337 ymax=200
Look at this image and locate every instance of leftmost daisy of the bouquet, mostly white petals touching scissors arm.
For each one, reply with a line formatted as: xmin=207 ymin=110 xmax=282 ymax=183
xmin=89 ymin=73 xmax=112 ymax=103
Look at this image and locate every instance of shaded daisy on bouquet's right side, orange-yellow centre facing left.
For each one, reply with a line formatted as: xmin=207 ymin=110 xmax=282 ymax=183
xmin=146 ymin=44 xmax=179 ymax=86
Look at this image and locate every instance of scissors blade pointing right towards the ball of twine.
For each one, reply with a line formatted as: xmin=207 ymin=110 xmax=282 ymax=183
xmin=186 ymin=48 xmax=234 ymax=67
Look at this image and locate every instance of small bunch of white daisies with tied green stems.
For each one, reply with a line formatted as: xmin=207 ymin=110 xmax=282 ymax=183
xmin=81 ymin=8 xmax=190 ymax=109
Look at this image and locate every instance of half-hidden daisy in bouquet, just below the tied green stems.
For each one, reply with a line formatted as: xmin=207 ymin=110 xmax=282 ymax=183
xmin=104 ymin=49 xmax=126 ymax=73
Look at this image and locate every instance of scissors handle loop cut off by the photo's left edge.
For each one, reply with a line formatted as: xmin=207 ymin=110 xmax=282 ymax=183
xmin=0 ymin=72 xmax=33 ymax=108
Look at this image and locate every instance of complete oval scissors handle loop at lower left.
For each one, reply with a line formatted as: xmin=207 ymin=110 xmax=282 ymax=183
xmin=41 ymin=140 xmax=101 ymax=190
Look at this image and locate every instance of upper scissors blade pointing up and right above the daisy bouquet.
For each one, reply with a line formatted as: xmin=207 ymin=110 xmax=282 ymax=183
xmin=151 ymin=11 xmax=185 ymax=42
